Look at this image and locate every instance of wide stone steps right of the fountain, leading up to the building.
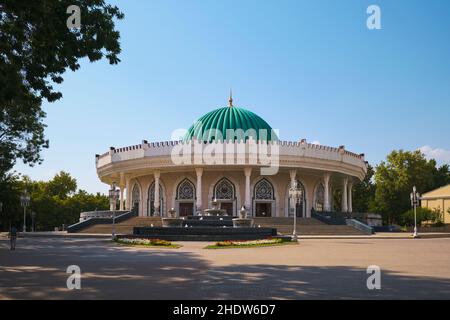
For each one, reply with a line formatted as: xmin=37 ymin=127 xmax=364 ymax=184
xmin=255 ymin=218 xmax=364 ymax=235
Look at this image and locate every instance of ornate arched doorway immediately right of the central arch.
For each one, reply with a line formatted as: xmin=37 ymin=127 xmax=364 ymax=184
xmin=253 ymin=178 xmax=276 ymax=217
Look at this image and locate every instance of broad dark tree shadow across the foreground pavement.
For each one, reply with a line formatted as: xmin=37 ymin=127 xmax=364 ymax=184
xmin=0 ymin=238 xmax=450 ymax=300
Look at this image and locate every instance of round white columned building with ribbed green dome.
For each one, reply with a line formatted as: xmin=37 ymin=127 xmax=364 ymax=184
xmin=96 ymin=97 xmax=367 ymax=218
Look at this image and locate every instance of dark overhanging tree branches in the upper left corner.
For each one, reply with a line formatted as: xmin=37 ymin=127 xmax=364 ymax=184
xmin=0 ymin=0 xmax=124 ymax=176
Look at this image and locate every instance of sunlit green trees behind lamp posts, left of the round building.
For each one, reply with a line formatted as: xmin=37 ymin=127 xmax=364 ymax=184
xmin=0 ymin=171 xmax=109 ymax=231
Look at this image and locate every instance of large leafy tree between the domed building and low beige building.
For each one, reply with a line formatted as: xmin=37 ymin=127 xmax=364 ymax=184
xmin=370 ymin=150 xmax=445 ymax=223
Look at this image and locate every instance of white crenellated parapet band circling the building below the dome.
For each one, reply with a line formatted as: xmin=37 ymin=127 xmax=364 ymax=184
xmin=96 ymin=137 xmax=367 ymax=179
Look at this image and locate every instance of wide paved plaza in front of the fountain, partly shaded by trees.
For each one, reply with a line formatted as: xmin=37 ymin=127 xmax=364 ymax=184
xmin=0 ymin=237 xmax=450 ymax=299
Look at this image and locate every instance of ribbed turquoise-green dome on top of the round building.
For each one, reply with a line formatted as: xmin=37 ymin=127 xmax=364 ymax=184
xmin=183 ymin=106 xmax=277 ymax=142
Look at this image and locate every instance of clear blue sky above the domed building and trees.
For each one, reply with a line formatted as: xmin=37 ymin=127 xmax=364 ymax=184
xmin=15 ymin=0 xmax=450 ymax=192
